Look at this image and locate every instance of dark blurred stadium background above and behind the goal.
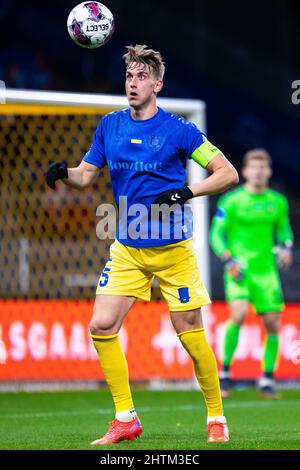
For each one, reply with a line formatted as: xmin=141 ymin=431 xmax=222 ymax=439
xmin=0 ymin=0 xmax=300 ymax=301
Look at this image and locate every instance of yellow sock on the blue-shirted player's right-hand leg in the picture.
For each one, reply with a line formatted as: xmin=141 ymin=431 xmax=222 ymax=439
xmin=177 ymin=328 xmax=223 ymax=417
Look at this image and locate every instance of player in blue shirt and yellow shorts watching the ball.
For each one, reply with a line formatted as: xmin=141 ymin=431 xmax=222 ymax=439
xmin=46 ymin=45 xmax=238 ymax=445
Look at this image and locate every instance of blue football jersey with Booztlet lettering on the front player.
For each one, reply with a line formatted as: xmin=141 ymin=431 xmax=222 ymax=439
xmin=83 ymin=108 xmax=205 ymax=247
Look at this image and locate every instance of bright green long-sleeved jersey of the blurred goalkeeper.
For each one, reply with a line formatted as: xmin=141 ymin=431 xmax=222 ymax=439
xmin=210 ymin=186 xmax=293 ymax=270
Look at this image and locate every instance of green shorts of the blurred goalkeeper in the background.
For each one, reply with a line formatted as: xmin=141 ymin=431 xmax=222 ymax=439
xmin=224 ymin=268 xmax=284 ymax=314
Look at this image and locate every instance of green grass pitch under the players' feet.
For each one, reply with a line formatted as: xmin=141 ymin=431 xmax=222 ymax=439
xmin=0 ymin=390 xmax=300 ymax=452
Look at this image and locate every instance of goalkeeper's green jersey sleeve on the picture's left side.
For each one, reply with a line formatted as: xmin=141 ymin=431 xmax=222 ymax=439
xmin=209 ymin=196 xmax=229 ymax=257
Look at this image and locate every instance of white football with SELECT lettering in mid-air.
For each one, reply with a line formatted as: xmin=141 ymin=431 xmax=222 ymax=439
xmin=67 ymin=2 xmax=115 ymax=49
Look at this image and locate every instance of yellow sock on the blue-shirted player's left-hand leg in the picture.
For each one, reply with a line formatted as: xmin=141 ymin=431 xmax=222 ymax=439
xmin=91 ymin=334 xmax=133 ymax=413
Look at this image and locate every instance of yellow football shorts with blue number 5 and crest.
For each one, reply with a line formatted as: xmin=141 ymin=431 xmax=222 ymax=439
xmin=96 ymin=238 xmax=211 ymax=311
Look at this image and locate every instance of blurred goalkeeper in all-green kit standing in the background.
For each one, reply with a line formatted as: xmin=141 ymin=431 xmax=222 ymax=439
xmin=210 ymin=148 xmax=293 ymax=398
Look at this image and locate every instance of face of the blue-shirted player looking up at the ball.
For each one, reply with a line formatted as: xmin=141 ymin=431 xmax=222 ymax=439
xmin=125 ymin=62 xmax=162 ymax=109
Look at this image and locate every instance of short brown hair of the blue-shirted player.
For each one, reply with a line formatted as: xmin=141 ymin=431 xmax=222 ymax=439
xmin=123 ymin=44 xmax=165 ymax=80
